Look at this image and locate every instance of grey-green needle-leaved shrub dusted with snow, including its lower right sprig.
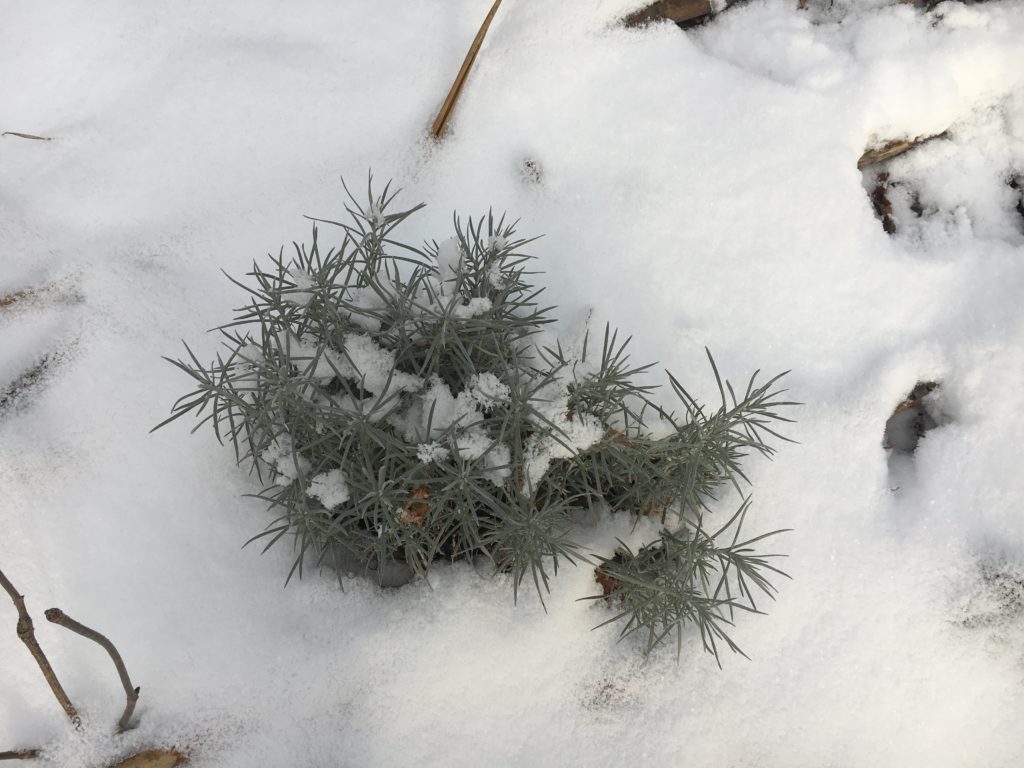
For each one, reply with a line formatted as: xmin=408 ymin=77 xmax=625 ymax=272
xmin=160 ymin=180 xmax=793 ymax=656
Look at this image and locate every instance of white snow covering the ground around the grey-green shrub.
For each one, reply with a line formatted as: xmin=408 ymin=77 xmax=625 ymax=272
xmin=0 ymin=0 xmax=1024 ymax=768
